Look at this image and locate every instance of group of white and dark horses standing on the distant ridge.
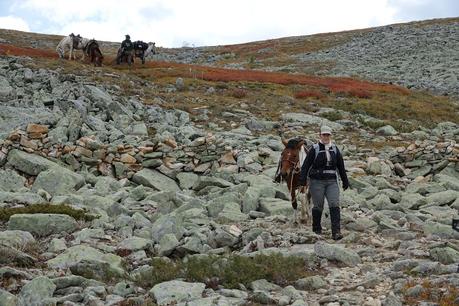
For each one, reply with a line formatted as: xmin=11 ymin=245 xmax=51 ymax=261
xmin=56 ymin=33 xmax=156 ymax=67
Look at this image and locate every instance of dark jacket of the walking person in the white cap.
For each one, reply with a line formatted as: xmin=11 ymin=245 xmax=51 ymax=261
xmin=299 ymin=142 xmax=349 ymax=189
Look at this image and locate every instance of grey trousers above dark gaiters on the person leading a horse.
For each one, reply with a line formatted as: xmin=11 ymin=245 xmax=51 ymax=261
xmin=309 ymin=179 xmax=339 ymax=211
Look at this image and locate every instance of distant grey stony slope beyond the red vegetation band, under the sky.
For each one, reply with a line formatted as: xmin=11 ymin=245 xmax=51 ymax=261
xmin=0 ymin=18 xmax=459 ymax=97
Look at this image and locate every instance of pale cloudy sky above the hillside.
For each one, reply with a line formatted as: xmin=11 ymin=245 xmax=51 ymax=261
xmin=0 ymin=0 xmax=459 ymax=47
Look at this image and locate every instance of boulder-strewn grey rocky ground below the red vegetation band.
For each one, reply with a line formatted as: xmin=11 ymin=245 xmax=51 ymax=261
xmin=0 ymin=17 xmax=459 ymax=306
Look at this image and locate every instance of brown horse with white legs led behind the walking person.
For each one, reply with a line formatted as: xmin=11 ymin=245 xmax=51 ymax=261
xmin=278 ymin=139 xmax=311 ymax=223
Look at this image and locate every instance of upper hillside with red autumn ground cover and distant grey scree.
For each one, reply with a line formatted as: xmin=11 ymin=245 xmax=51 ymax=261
xmin=0 ymin=19 xmax=459 ymax=131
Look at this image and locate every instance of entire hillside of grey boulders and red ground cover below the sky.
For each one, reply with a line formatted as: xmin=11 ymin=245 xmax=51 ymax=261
xmin=0 ymin=18 xmax=459 ymax=306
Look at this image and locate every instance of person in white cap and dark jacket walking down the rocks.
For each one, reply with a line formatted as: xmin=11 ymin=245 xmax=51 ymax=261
xmin=299 ymin=125 xmax=349 ymax=240
